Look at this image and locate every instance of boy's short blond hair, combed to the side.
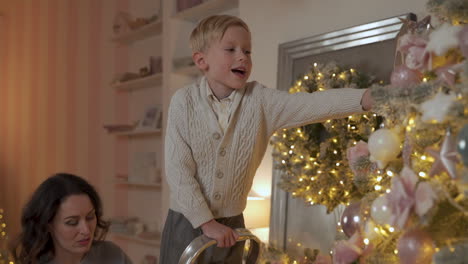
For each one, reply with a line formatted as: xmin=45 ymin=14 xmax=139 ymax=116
xmin=190 ymin=15 xmax=250 ymax=52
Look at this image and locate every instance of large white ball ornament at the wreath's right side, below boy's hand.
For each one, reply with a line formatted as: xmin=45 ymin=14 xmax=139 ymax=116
xmin=368 ymin=128 xmax=400 ymax=169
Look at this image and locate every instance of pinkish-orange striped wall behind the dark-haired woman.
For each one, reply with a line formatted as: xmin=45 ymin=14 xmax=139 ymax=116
xmin=0 ymin=0 xmax=128 ymax=233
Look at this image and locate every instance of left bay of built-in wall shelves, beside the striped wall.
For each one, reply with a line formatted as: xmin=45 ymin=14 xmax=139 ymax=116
xmin=108 ymin=0 xmax=165 ymax=263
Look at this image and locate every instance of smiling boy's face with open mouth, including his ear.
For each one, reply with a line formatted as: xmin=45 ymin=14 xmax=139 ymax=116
xmin=194 ymin=26 xmax=252 ymax=94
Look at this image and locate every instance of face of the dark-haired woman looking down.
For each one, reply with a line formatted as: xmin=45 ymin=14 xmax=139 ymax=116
xmin=50 ymin=194 xmax=96 ymax=256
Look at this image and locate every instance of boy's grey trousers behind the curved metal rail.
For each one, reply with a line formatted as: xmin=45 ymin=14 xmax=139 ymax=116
xmin=159 ymin=209 xmax=245 ymax=264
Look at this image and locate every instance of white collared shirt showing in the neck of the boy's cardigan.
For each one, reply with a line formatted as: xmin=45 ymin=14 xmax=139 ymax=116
xmin=206 ymin=85 xmax=236 ymax=133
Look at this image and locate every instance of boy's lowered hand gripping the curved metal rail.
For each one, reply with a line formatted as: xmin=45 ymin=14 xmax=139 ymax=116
xmin=201 ymin=219 xmax=239 ymax=247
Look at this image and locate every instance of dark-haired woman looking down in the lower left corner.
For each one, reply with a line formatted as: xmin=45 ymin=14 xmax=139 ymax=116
xmin=12 ymin=173 xmax=131 ymax=264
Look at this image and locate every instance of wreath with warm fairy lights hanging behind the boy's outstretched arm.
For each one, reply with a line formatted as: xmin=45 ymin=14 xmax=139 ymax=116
xmin=271 ymin=63 xmax=379 ymax=212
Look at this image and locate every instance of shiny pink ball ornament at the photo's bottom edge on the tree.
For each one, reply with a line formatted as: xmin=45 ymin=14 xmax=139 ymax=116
xmin=397 ymin=228 xmax=434 ymax=264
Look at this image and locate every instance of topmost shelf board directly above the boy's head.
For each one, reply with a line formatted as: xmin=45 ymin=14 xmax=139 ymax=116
xmin=174 ymin=0 xmax=239 ymax=22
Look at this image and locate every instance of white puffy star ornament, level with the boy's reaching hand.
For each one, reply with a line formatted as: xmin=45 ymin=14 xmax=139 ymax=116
xmin=420 ymin=92 xmax=456 ymax=123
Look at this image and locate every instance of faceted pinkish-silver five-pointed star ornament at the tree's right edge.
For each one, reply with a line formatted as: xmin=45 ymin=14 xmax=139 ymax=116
xmin=427 ymin=130 xmax=458 ymax=179
